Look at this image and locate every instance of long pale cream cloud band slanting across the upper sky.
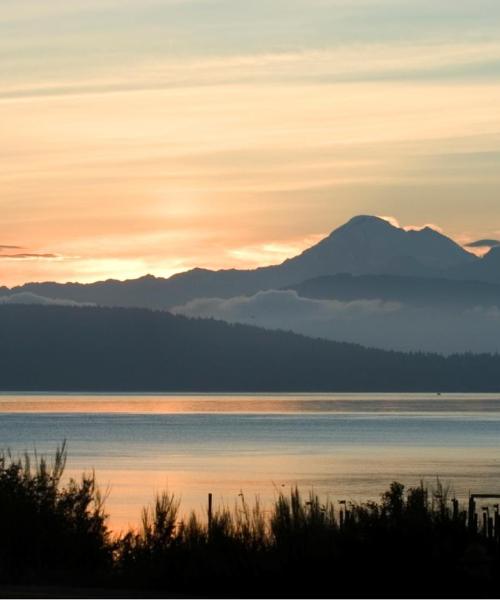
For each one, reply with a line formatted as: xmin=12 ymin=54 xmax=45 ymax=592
xmin=0 ymin=41 xmax=500 ymax=100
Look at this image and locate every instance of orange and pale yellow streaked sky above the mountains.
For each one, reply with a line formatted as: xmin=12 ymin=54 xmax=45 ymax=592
xmin=0 ymin=0 xmax=500 ymax=285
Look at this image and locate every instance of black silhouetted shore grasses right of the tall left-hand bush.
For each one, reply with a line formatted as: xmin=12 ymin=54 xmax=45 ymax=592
xmin=115 ymin=480 xmax=500 ymax=597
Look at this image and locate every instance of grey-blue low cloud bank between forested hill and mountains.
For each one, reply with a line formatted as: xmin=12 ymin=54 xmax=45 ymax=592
xmin=172 ymin=291 xmax=500 ymax=354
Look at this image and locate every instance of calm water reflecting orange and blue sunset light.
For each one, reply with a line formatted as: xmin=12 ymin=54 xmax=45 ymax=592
xmin=0 ymin=394 xmax=500 ymax=530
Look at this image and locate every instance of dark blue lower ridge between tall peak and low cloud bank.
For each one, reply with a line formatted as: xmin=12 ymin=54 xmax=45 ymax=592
xmin=287 ymin=274 xmax=500 ymax=309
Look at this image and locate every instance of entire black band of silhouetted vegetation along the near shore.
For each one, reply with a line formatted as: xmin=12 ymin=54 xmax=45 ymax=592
xmin=0 ymin=447 xmax=500 ymax=598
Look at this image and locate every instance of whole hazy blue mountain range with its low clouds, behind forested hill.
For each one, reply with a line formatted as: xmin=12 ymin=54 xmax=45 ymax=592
xmin=0 ymin=215 xmax=500 ymax=360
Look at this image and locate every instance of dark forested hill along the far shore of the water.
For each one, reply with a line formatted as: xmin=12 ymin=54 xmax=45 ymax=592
xmin=0 ymin=305 xmax=500 ymax=392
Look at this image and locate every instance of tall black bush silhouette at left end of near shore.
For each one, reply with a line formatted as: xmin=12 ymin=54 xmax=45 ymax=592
xmin=0 ymin=443 xmax=112 ymax=582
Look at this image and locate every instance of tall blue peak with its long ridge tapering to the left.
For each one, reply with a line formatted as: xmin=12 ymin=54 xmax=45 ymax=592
xmin=5 ymin=215 xmax=480 ymax=308
